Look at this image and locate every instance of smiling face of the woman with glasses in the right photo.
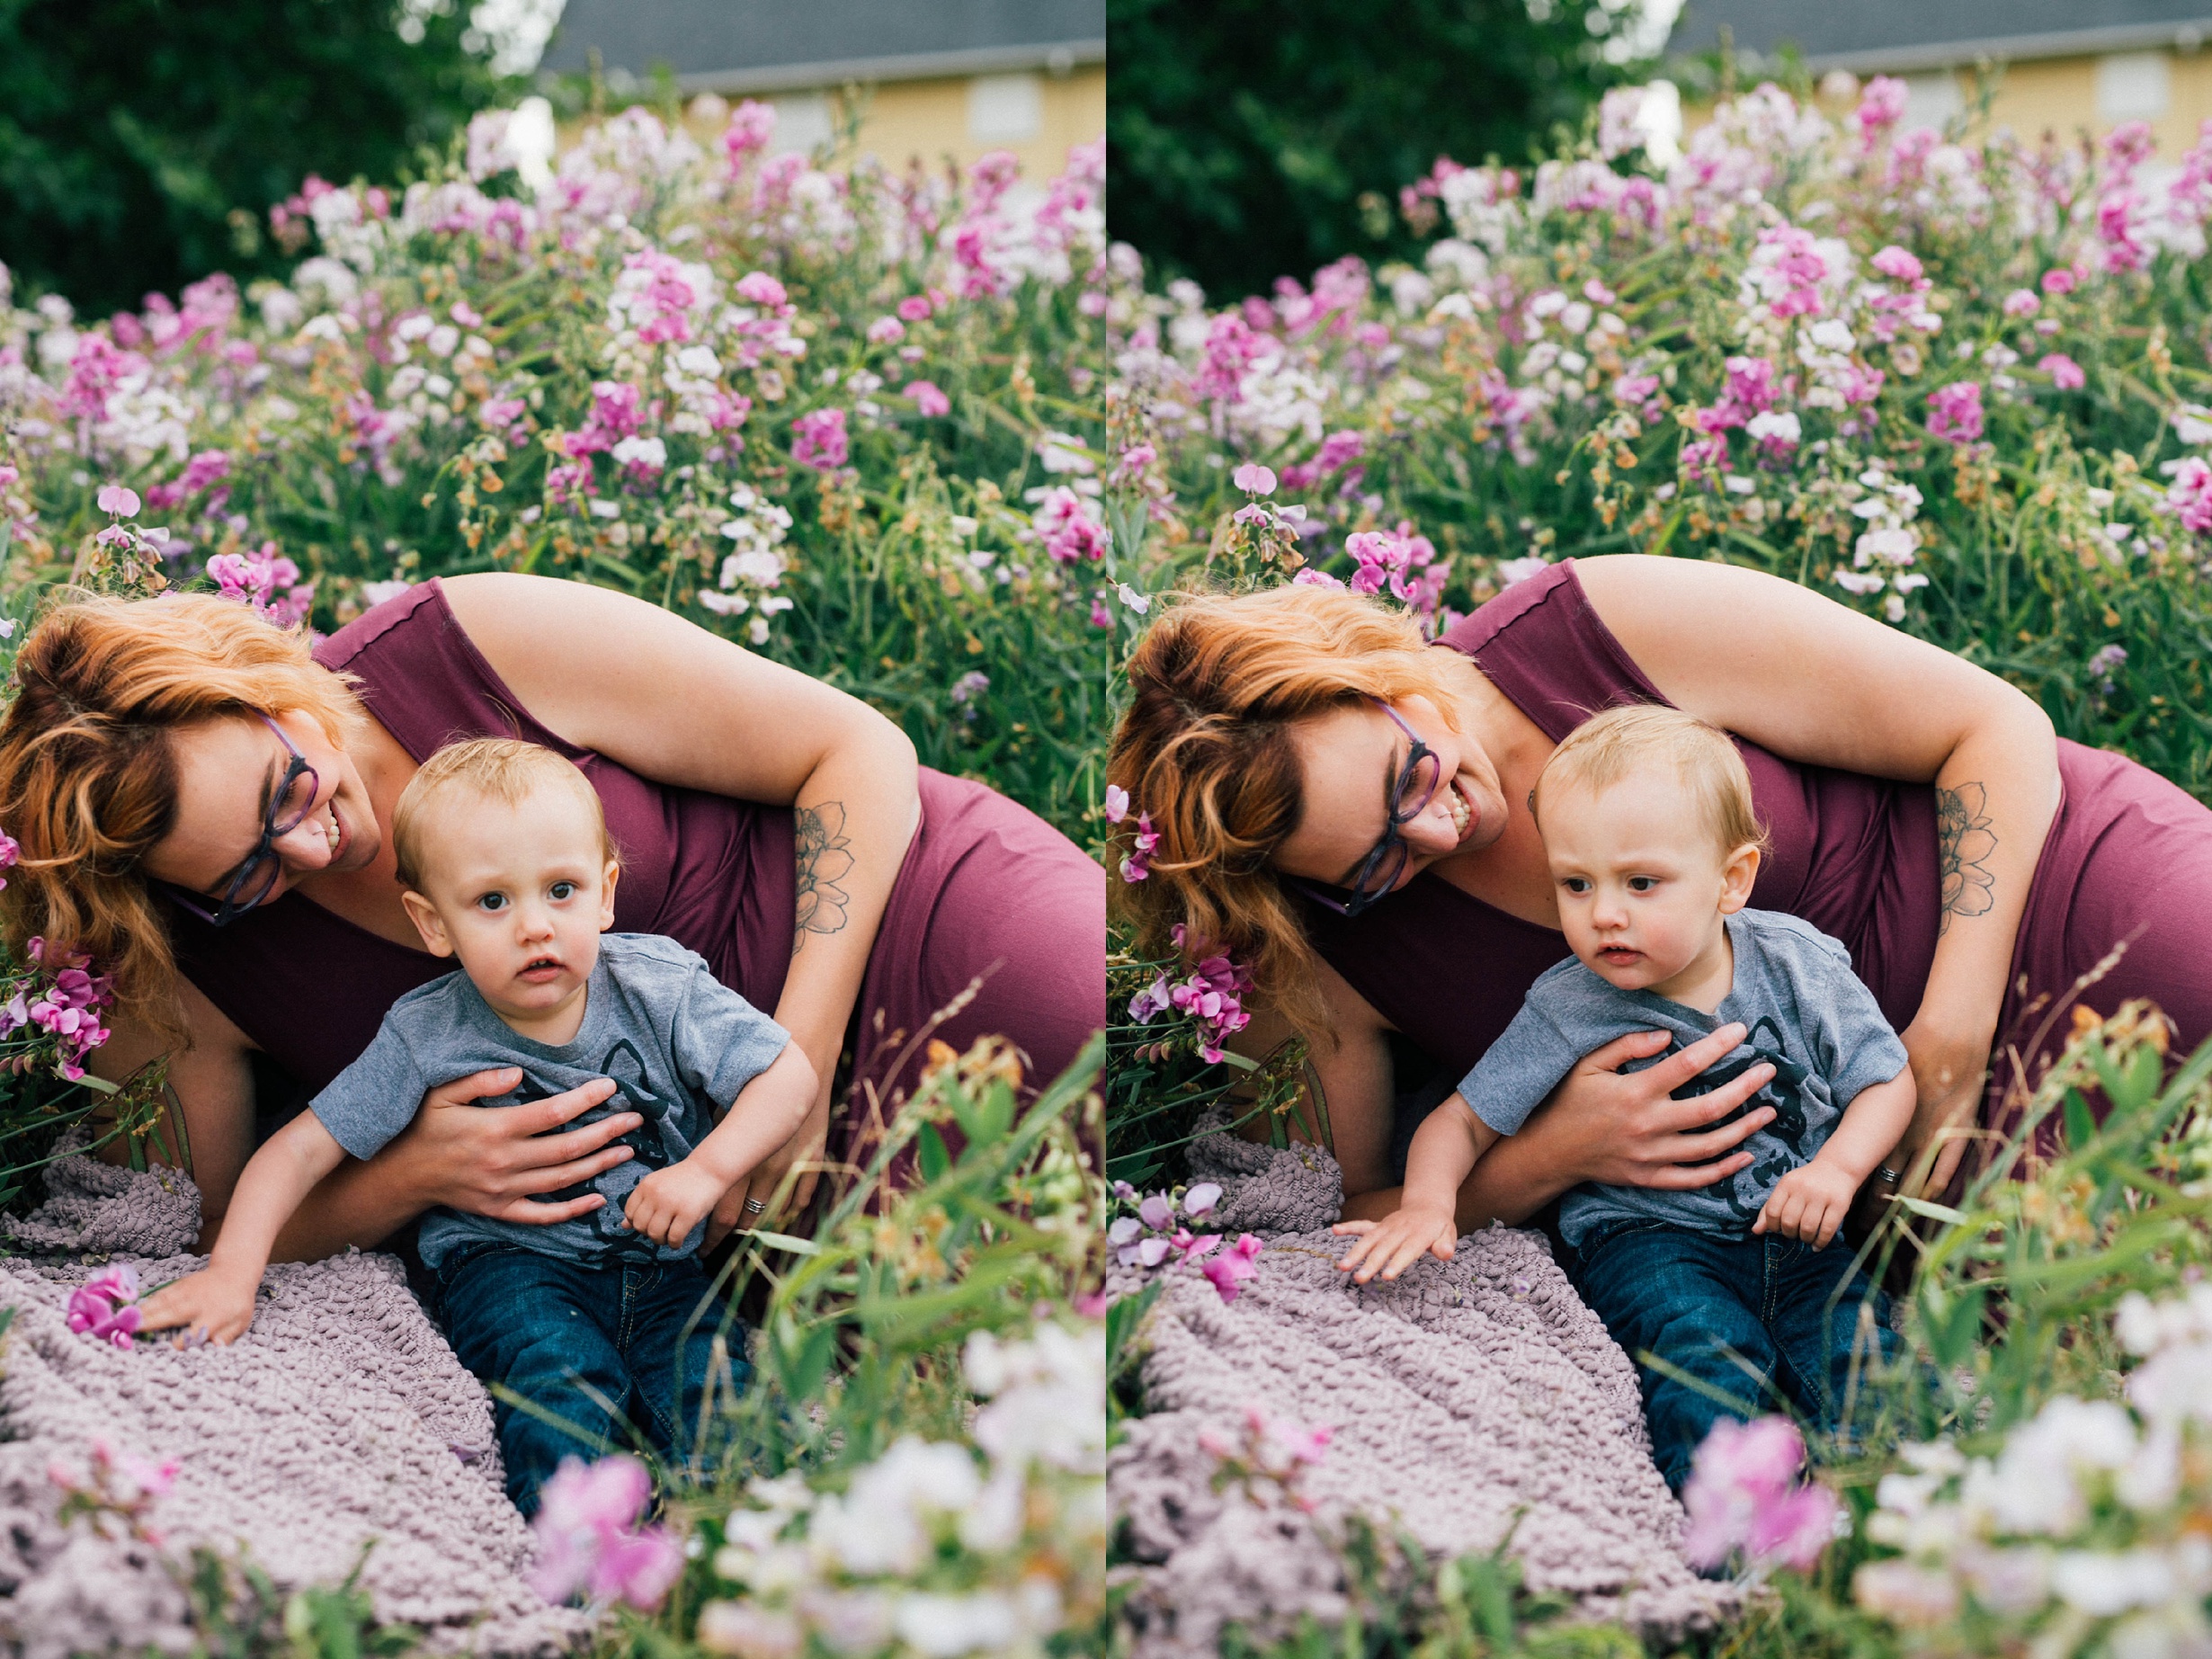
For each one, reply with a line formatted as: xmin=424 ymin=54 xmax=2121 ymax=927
xmin=1274 ymin=697 xmax=1506 ymax=902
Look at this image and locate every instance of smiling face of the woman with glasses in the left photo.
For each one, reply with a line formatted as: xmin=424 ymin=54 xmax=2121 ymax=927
xmin=146 ymin=712 xmax=383 ymax=909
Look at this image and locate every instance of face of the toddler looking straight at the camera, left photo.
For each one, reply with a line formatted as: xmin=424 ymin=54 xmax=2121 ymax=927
xmin=403 ymin=788 xmax=620 ymax=1024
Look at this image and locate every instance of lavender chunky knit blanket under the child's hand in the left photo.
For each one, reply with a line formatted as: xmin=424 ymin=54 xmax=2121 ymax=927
xmin=0 ymin=1157 xmax=584 ymax=1659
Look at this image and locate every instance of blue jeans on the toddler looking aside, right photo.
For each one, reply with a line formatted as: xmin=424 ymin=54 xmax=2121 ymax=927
xmin=1575 ymin=1221 xmax=1895 ymax=1494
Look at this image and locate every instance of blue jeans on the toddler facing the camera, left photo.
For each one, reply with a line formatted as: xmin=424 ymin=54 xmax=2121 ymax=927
xmin=436 ymin=1241 xmax=752 ymax=1515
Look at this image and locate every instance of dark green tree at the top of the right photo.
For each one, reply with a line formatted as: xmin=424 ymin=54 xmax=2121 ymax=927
xmin=1106 ymin=0 xmax=1632 ymax=301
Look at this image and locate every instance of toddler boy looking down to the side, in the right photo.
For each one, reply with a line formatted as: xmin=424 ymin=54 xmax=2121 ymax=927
xmin=1338 ymin=706 xmax=1915 ymax=1491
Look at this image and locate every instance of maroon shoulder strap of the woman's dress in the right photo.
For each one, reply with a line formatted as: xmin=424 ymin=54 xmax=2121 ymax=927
xmin=1438 ymin=559 xmax=1665 ymax=744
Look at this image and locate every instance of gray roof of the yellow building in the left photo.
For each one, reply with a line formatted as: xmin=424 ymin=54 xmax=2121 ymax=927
xmin=540 ymin=0 xmax=1106 ymax=93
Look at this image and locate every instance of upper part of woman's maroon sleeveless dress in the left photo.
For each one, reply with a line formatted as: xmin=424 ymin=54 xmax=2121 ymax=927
xmin=170 ymin=580 xmax=797 ymax=1091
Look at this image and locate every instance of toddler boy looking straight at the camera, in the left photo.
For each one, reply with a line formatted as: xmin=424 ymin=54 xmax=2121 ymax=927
xmin=146 ymin=739 xmax=814 ymax=1515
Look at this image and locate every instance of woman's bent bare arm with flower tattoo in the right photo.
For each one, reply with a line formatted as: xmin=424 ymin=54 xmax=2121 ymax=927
xmin=1575 ymin=555 xmax=2059 ymax=1188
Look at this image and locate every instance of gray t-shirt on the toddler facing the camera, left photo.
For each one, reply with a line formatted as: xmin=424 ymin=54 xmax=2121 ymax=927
xmin=312 ymin=933 xmax=792 ymax=1268
